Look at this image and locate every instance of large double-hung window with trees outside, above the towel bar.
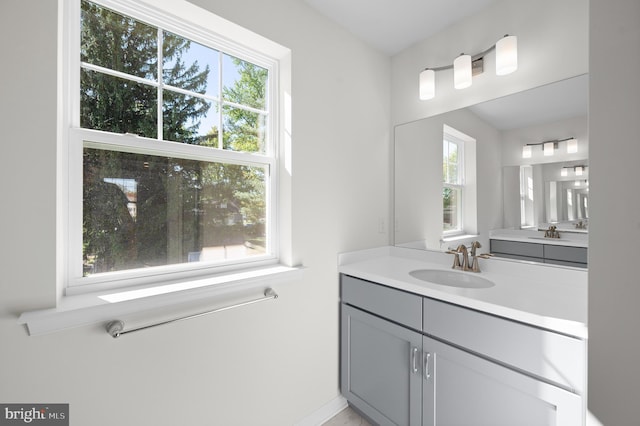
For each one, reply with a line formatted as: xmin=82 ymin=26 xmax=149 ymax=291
xmin=65 ymin=0 xmax=278 ymax=288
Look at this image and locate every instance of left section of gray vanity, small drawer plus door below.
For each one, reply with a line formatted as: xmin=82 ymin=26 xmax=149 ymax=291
xmin=340 ymin=275 xmax=422 ymax=426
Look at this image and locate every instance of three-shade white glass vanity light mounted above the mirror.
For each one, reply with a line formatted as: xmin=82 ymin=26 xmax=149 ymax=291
xmin=419 ymin=34 xmax=518 ymax=101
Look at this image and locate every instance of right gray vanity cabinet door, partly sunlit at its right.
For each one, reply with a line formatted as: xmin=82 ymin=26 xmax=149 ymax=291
xmin=423 ymin=337 xmax=582 ymax=426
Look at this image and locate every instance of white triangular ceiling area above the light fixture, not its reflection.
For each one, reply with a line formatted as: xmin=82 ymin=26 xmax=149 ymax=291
xmin=303 ymin=0 xmax=495 ymax=56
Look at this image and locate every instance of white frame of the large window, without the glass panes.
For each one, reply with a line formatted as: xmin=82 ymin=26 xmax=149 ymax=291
xmin=58 ymin=0 xmax=281 ymax=295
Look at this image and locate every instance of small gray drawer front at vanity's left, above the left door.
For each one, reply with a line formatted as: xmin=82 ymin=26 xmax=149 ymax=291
xmin=340 ymin=275 xmax=422 ymax=330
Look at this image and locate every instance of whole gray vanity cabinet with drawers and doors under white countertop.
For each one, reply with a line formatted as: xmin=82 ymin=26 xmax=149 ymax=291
xmin=340 ymin=275 xmax=586 ymax=426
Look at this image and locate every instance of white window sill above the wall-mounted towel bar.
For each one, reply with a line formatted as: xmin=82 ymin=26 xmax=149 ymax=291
xmin=18 ymin=265 xmax=302 ymax=336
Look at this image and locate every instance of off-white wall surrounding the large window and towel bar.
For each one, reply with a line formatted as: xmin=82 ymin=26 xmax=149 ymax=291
xmin=0 ymin=0 xmax=390 ymax=426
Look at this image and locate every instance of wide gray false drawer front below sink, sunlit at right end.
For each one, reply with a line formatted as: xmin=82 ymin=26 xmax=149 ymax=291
xmin=424 ymin=298 xmax=586 ymax=394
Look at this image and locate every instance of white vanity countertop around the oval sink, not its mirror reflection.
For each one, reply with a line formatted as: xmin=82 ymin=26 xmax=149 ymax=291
xmin=338 ymin=246 xmax=587 ymax=338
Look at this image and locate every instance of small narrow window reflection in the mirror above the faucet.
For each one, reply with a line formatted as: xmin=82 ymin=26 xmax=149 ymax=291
xmin=442 ymin=133 xmax=464 ymax=235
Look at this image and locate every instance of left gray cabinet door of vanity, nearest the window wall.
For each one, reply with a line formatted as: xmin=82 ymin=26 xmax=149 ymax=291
xmin=340 ymin=304 xmax=422 ymax=426
